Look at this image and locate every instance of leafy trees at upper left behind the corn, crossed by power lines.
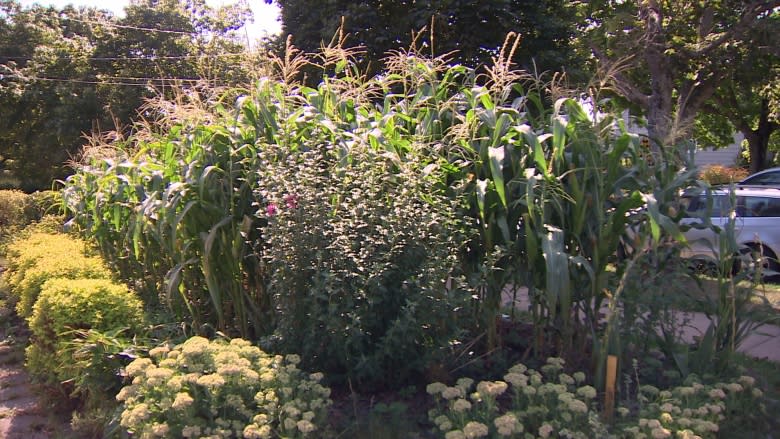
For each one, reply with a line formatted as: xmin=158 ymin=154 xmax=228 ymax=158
xmin=0 ymin=0 xmax=250 ymax=191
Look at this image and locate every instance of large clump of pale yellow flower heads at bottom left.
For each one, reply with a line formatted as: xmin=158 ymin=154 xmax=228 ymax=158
xmin=116 ymin=337 xmax=331 ymax=438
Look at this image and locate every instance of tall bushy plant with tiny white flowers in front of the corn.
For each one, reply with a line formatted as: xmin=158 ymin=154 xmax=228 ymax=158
xmin=258 ymin=142 xmax=469 ymax=390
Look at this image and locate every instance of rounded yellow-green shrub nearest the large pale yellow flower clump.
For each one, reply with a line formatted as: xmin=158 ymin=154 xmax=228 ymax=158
xmin=26 ymin=279 xmax=144 ymax=398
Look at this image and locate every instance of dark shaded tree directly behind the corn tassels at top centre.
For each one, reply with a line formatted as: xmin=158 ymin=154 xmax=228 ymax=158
xmin=265 ymin=0 xmax=580 ymax=76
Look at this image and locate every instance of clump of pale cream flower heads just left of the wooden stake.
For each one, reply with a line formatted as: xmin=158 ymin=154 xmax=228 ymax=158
xmin=426 ymin=358 xmax=606 ymax=439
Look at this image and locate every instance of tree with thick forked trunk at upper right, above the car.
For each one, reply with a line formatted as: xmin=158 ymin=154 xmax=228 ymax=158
xmin=586 ymin=0 xmax=780 ymax=150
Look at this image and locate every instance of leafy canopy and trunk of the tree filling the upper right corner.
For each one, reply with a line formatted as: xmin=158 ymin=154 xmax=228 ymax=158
xmin=581 ymin=1 xmax=778 ymax=152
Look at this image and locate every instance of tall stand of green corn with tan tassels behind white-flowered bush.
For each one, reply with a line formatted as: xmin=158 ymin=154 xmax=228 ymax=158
xmin=65 ymin=41 xmax=691 ymax=370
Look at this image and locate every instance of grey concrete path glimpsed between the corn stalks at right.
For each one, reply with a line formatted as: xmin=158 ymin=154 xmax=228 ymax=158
xmin=503 ymin=288 xmax=780 ymax=362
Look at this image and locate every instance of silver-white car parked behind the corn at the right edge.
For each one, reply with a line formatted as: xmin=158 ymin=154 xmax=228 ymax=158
xmin=681 ymin=186 xmax=780 ymax=275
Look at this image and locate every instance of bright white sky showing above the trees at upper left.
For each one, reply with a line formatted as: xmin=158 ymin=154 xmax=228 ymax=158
xmin=21 ymin=0 xmax=281 ymax=40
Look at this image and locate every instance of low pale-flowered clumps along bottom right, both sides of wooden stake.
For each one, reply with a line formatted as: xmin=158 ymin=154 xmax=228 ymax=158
xmin=426 ymin=358 xmax=762 ymax=439
